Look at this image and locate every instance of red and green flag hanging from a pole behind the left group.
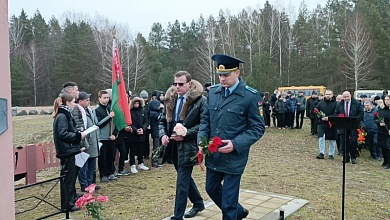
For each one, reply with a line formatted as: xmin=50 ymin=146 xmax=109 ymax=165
xmin=111 ymin=39 xmax=132 ymax=131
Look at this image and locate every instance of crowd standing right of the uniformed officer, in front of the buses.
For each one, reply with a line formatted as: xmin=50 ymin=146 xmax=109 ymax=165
xmin=263 ymin=89 xmax=390 ymax=166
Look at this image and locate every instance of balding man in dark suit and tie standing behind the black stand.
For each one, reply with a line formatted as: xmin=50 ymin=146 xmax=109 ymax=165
xmin=334 ymin=91 xmax=364 ymax=164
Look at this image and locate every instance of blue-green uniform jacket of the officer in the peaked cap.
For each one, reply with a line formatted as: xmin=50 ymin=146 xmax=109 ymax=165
xmin=198 ymin=80 xmax=265 ymax=174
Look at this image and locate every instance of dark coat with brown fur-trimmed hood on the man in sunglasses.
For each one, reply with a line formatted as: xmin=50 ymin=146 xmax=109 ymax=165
xmin=159 ymin=80 xmax=206 ymax=166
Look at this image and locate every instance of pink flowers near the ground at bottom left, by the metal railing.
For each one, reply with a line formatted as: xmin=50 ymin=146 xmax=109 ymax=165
xmin=75 ymin=184 xmax=108 ymax=220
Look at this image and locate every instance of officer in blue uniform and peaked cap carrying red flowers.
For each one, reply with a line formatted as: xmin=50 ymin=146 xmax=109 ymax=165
xmin=198 ymin=54 xmax=265 ymax=220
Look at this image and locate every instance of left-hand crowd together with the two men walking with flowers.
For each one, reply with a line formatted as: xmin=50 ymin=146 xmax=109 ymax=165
xmin=53 ymin=54 xmax=266 ymax=219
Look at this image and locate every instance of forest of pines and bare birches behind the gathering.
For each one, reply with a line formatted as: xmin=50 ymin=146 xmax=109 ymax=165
xmin=9 ymin=0 xmax=390 ymax=106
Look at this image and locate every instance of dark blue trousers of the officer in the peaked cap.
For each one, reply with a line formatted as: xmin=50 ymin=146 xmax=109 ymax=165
xmin=206 ymin=168 xmax=244 ymax=220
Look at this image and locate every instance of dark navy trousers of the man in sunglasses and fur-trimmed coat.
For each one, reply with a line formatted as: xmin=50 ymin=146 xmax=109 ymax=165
xmin=171 ymin=143 xmax=204 ymax=220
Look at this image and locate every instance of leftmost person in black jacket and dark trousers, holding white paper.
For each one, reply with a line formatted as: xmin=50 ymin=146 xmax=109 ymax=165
xmin=53 ymin=93 xmax=85 ymax=211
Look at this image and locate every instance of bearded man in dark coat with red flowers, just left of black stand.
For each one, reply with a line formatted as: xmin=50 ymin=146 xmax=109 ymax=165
xmin=316 ymin=90 xmax=337 ymax=160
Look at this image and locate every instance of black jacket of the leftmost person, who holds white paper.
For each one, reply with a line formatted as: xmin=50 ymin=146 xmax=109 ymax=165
xmin=53 ymin=106 xmax=81 ymax=159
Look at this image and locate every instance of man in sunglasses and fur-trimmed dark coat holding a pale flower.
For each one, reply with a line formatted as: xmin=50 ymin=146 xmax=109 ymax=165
xmin=159 ymin=71 xmax=206 ymax=220
